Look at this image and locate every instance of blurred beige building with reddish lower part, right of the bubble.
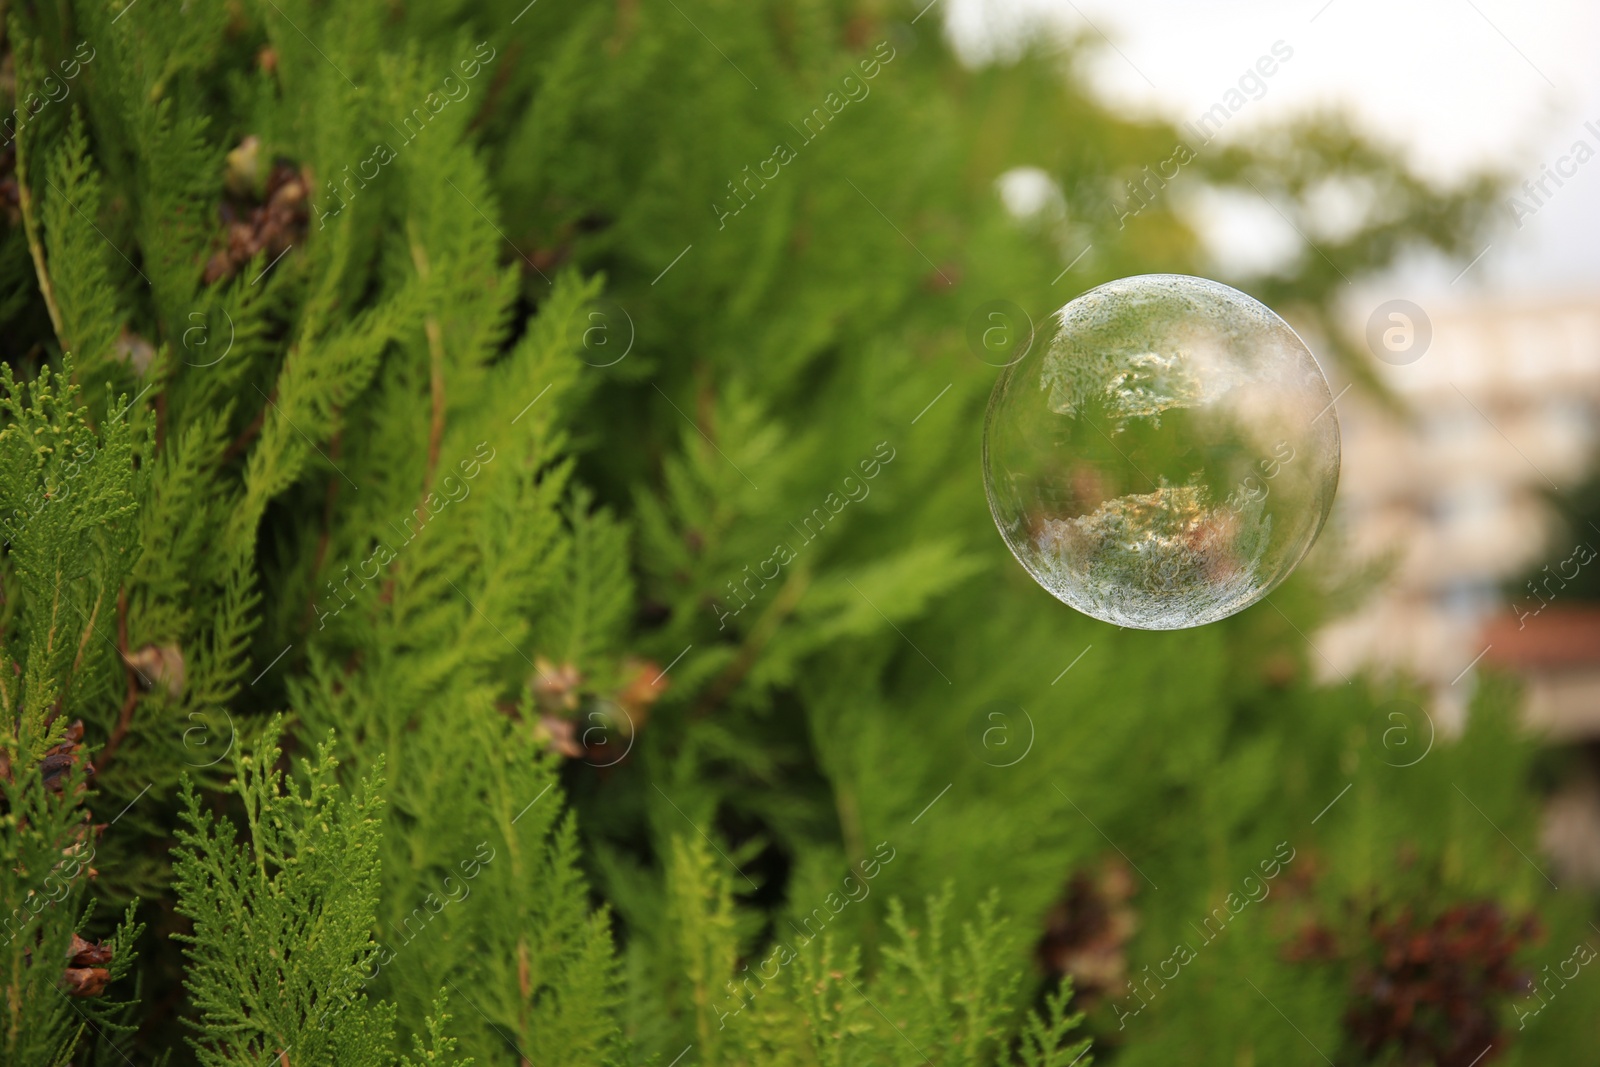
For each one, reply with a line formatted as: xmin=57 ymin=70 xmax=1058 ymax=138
xmin=1317 ymin=294 xmax=1600 ymax=739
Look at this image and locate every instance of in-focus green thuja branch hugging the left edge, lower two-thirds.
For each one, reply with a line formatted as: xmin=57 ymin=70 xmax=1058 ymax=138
xmin=0 ymin=360 xmax=141 ymax=1064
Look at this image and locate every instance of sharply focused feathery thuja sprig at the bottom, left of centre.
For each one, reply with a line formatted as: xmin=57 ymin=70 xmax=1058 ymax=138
xmin=173 ymin=720 xmax=470 ymax=1067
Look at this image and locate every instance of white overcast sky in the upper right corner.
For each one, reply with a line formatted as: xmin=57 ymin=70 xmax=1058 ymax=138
xmin=941 ymin=0 xmax=1600 ymax=294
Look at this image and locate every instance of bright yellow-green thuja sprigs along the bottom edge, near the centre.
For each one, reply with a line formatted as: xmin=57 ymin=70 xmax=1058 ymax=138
xmin=658 ymin=838 xmax=1093 ymax=1067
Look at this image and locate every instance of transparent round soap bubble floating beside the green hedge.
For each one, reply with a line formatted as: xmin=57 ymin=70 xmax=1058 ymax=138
xmin=984 ymin=274 xmax=1339 ymax=630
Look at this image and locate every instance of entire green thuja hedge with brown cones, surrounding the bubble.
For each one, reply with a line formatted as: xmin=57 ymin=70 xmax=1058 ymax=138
xmin=0 ymin=0 xmax=1600 ymax=1067
